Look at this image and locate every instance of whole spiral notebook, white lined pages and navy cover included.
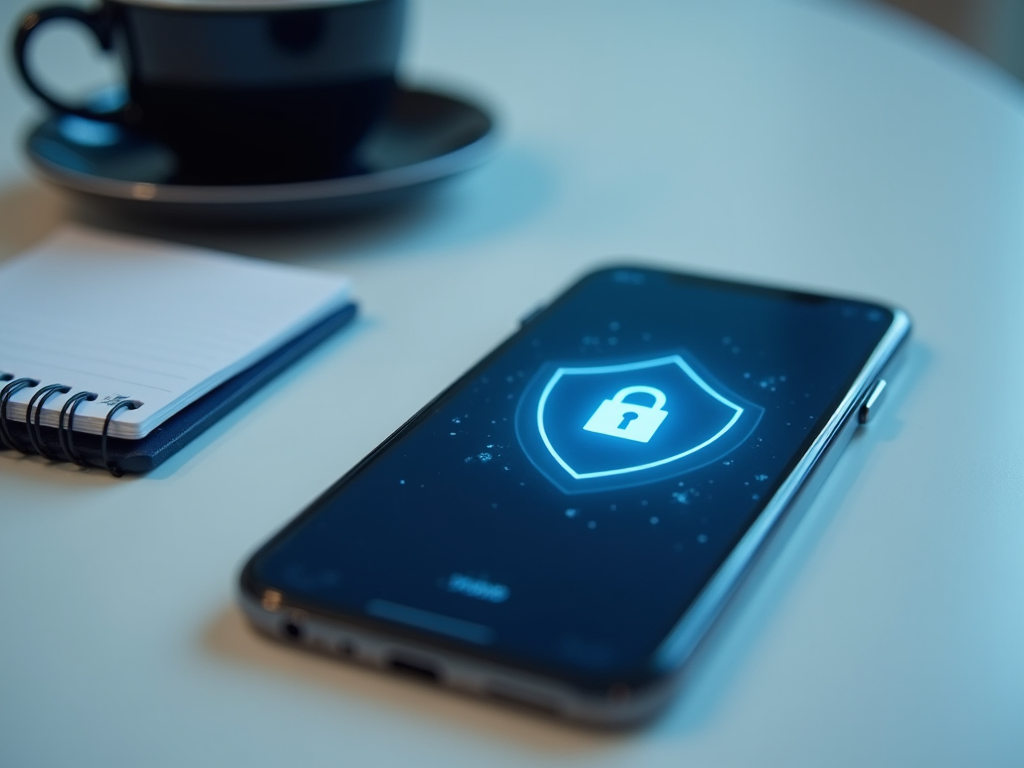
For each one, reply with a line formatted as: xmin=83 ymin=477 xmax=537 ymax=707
xmin=0 ymin=227 xmax=355 ymax=474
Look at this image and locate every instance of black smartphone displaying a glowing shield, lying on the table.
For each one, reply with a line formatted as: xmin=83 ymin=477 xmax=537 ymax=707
xmin=240 ymin=265 xmax=910 ymax=725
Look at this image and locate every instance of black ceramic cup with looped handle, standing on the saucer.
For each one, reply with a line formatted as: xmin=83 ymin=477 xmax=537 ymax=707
xmin=14 ymin=0 xmax=406 ymax=184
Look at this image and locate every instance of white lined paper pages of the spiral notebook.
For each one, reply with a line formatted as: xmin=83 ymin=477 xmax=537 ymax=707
xmin=0 ymin=227 xmax=351 ymax=440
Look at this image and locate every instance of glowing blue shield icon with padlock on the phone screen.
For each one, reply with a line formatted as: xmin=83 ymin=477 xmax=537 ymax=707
xmin=516 ymin=350 xmax=763 ymax=494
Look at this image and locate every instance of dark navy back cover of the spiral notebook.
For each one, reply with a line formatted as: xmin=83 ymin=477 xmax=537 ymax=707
xmin=0 ymin=303 xmax=356 ymax=472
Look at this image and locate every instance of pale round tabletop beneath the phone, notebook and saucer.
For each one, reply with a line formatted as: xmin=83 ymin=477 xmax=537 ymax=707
xmin=0 ymin=0 xmax=1024 ymax=768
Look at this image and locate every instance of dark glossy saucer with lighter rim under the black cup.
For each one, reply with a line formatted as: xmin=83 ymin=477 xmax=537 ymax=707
xmin=26 ymin=87 xmax=495 ymax=222
